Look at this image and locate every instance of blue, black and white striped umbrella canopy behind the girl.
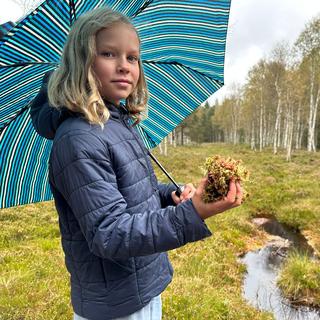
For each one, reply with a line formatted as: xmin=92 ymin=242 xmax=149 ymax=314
xmin=0 ymin=0 xmax=231 ymax=208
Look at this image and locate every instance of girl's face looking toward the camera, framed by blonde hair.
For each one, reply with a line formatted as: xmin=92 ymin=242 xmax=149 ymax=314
xmin=93 ymin=23 xmax=140 ymax=105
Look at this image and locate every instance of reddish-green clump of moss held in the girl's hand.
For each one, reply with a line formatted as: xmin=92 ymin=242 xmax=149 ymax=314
xmin=202 ymin=155 xmax=249 ymax=203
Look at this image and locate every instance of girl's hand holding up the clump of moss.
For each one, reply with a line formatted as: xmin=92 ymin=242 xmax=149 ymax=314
xmin=192 ymin=178 xmax=243 ymax=220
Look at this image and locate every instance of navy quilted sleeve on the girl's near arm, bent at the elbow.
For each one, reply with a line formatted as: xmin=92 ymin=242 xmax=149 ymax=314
xmin=50 ymin=131 xmax=211 ymax=259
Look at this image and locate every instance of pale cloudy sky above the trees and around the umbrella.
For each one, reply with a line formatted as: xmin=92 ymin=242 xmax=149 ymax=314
xmin=0 ymin=0 xmax=320 ymax=103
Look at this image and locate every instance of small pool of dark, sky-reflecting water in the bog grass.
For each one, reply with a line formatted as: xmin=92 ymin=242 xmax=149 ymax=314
xmin=241 ymin=218 xmax=320 ymax=320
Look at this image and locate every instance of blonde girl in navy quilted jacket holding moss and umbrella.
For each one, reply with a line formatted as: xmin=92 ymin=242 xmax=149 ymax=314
xmin=31 ymin=8 xmax=242 ymax=320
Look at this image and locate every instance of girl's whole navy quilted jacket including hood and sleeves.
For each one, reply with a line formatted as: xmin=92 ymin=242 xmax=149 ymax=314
xmin=31 ymin=74 xmax=211 ymax=320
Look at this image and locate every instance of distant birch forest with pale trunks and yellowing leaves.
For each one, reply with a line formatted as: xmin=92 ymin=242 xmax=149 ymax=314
xmin=168 ymin=16 xmax=320 ymax=160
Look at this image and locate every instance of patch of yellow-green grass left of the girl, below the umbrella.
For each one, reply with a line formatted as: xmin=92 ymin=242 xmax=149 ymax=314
xmin=0 ymin=201 xmax=72 ymax=320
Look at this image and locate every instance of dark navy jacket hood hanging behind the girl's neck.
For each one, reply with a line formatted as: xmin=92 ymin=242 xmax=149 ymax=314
xmin=30 ymin=72 xmax=72 ymax=140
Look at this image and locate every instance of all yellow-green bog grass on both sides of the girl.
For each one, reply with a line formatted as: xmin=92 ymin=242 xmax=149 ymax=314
xmin=0 ymin=144 xmax=320 ymax=320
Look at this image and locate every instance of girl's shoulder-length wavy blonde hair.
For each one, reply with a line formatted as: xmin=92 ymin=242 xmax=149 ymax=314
xmin=48 ymin=8 xmax=148 ymax=128
